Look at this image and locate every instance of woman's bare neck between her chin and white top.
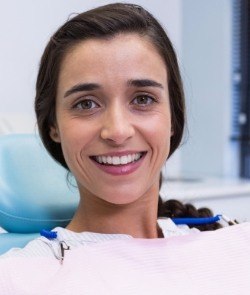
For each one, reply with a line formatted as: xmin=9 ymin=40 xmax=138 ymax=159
xmin=67 ymin=189 xmax=161 ymax=239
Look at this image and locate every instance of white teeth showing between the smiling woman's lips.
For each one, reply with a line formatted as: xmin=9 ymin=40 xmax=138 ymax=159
xmin=90 ymin=152 xmax=147 ymax=166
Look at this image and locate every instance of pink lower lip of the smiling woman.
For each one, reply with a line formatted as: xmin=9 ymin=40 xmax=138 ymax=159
xmin=91 ymin=153 xmax=146 ymax=175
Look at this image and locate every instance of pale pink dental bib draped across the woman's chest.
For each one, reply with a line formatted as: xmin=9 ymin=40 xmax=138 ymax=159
xmin=0 ymin=223 xmax=250 ymax=295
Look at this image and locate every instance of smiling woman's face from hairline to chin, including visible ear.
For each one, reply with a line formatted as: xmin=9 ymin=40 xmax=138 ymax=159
xmin=51 ymin=34 xmax=171 ymax=204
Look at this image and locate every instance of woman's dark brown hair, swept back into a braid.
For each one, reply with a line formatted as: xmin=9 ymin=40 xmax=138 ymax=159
xmin=35 ymin=3 xmax=221 ymax=232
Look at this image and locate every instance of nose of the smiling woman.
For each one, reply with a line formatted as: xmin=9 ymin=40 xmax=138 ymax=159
xmin=101 ymin=105 xmax=135 ymax=145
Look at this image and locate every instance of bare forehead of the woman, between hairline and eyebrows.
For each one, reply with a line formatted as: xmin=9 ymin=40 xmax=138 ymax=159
xmin=59 ymin=34 xmax=167 ymax=90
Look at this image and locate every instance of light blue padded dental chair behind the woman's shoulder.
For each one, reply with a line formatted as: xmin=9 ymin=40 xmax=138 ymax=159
xmin=0 ymin=134 xmax=79 ymax=255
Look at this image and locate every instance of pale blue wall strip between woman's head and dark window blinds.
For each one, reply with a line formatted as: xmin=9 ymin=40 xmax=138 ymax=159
xmin=181 ymin=0 xmax=233 ymax=177
